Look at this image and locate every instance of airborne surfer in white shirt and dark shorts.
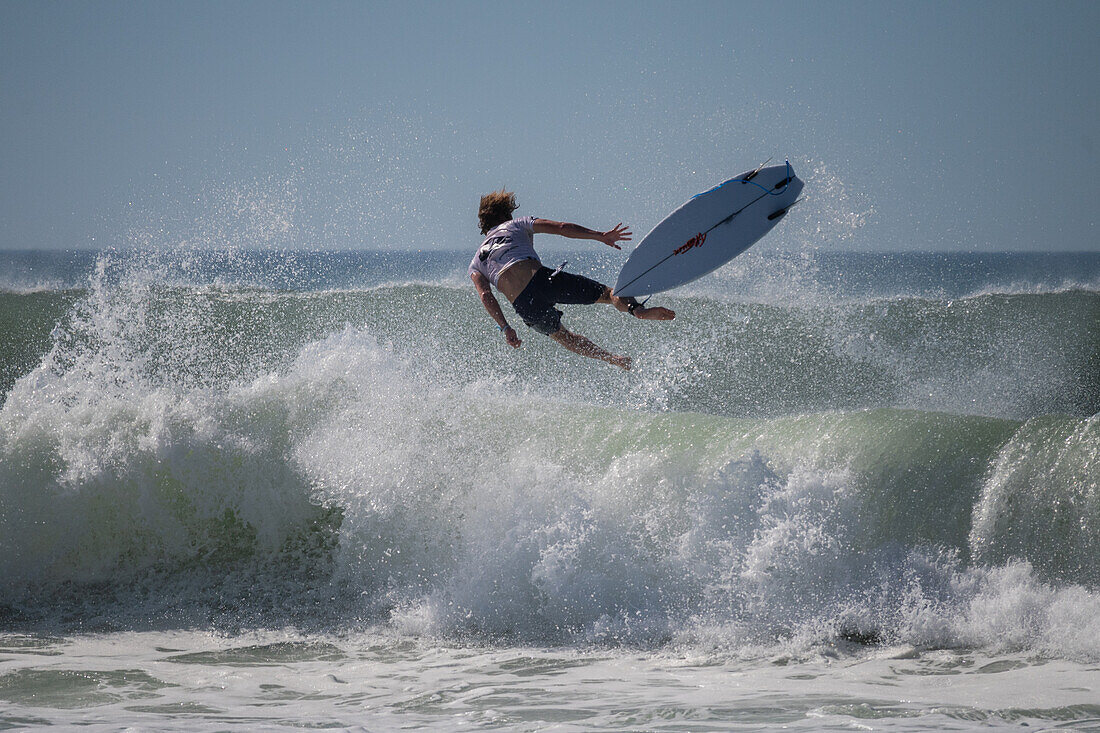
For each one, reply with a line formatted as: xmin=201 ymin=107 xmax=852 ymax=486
xmin=470 ymin=189 xmax=677 ymax=370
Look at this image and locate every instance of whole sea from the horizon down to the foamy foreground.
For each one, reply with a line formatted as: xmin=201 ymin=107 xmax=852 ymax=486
xmin=0 ymin=242 xmax=1100 ymax=732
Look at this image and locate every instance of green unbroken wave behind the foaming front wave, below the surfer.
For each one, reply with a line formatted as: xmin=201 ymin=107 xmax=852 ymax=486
xmin=0 ymin=284 xmax=1100 ymax=419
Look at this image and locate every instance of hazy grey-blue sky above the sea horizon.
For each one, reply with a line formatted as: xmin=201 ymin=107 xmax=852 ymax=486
xmin=0 ymin=0 xmax=1100 ymax=251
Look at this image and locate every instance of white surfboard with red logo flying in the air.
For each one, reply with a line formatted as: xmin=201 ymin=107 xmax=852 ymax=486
xmin=615 ymin=163 xmax=803 ymax=297
